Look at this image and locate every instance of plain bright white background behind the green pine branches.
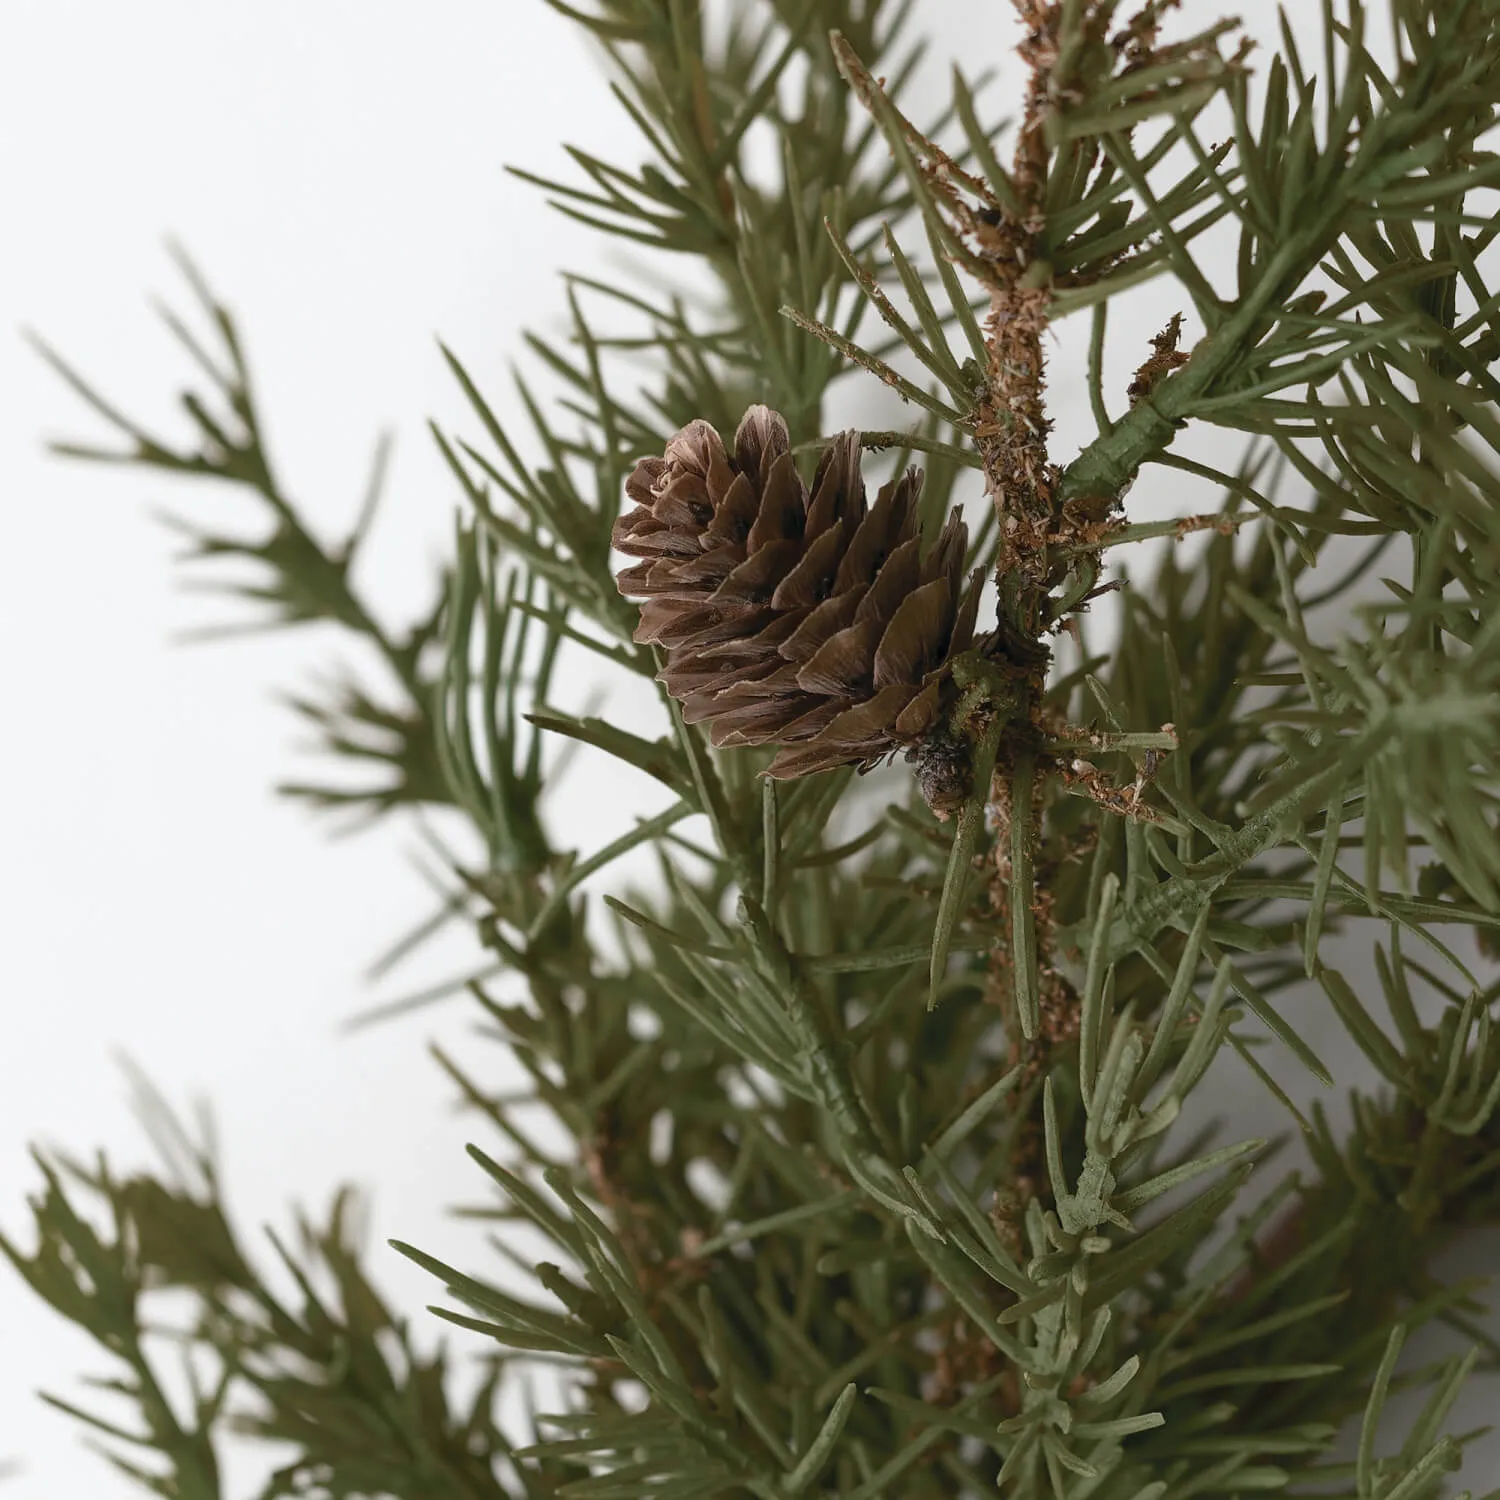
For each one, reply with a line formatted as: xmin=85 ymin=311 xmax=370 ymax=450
xmin=0 ymin=0 xmax=1500 ymax=1500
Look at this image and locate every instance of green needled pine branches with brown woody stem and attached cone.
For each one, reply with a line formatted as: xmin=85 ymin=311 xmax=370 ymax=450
xmin=0 ymin=0 xmax=1500 ymax=1500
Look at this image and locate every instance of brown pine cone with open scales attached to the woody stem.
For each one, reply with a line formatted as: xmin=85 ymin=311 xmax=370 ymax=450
xmin=614 ymin=407 xmax=983 ymax=777
